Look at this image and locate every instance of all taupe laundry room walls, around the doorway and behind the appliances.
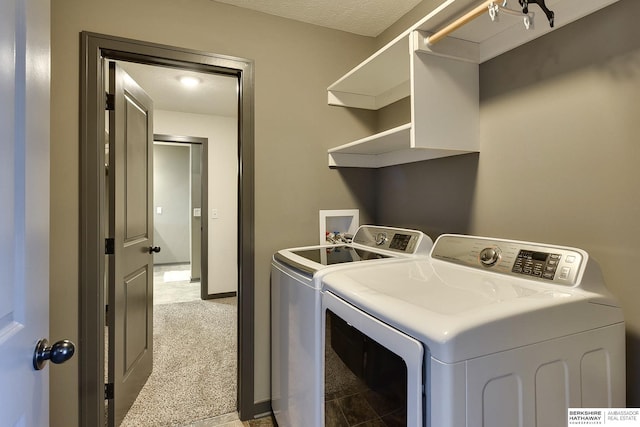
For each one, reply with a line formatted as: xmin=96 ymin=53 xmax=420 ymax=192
xmin=50 ymin=0 xmax=640 ymax=427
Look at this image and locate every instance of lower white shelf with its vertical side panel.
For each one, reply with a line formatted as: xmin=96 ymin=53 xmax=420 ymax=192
xmin=328 ymin=44 xmax=479 ymax=168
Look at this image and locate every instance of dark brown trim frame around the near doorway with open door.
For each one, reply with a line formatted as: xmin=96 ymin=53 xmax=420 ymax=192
xmin=79 ymin=33 xmax=256 ymax=425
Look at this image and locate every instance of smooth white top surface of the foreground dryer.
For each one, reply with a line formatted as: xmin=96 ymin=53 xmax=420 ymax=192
xmin=323 ymin=259 xmax=623 ymax=363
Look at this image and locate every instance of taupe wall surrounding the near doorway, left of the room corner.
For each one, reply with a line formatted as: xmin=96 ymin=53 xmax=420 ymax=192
xmin=50 ymin=0 xmax=375 ymax=427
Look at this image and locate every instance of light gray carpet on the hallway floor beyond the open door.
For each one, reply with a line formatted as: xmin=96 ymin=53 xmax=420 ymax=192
xmin=121 ymin=298 xmax=237 ymax=427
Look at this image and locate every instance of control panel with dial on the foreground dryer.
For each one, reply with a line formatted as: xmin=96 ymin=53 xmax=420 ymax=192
xmin=431 ymin=234 xmax=588 ymax=286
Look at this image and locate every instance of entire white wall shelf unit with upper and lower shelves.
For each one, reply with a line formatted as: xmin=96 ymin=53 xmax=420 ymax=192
xmin=327 ymin=0 xmax=618 ymax=167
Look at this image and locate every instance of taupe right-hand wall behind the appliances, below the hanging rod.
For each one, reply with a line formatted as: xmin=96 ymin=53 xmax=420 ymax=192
xmin=378 ymin=0 xmax=640 ymax=406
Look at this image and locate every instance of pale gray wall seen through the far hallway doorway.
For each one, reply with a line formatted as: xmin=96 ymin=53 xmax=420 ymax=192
xmin=153 ymin=144 xmax=191 ymax=264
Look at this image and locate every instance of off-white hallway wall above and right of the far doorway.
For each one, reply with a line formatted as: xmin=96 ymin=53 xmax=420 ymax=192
xmin=153 ymin=110 xmax=238 ymax=294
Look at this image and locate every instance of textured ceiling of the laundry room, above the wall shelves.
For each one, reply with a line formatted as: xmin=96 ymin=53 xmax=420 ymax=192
xmin=212 ymin=0 xmax=428 ymax=37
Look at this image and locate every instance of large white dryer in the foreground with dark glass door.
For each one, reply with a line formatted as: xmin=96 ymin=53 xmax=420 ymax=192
xmin=322 ymin=235 xmax=625 ymax=427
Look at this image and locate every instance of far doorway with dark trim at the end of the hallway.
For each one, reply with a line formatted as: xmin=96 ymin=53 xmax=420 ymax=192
xmin=151 ymin=134 xmax=209 ymax=304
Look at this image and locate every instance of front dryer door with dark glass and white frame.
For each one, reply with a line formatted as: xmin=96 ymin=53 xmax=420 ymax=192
xmin=321 ymin=292 xmax=424 ymax=426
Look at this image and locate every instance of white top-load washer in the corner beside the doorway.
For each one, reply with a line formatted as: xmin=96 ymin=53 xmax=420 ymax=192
xmin=271 ymin=225 xmax=433 ymax=427
